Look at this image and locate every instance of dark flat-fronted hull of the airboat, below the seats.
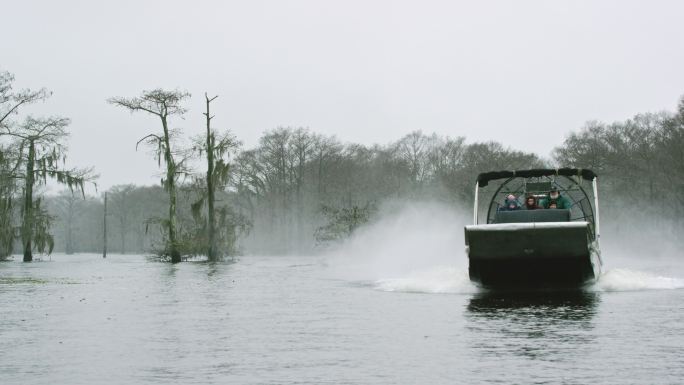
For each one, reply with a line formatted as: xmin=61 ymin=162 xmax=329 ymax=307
xmin=465 ymin=222 xmax=601 ymax=289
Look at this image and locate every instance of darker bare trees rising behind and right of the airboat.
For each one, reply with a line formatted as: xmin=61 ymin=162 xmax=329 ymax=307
xmin=553 ymin=98 xmax=684 ymax=240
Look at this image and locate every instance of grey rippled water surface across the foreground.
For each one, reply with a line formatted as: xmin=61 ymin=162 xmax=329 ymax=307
xmin=0 ymin=255 xmax=684 ymax=385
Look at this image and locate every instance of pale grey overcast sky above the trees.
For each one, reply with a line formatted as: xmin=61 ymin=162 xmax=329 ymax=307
xmin=0 ymin=0 xmax=684 ymax=191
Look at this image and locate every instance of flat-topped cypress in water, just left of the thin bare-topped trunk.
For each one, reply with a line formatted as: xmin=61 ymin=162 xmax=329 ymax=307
xmin=108 ymin=89 xmax=190 ymax=263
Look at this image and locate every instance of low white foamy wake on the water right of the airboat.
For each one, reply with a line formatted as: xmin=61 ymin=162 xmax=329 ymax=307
xmin=593 ymin=269 xmax=684 ymax=291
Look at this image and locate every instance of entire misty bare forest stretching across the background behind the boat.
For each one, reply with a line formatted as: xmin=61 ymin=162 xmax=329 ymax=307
xmin=0 ymin=73 xmax=684 ymax=257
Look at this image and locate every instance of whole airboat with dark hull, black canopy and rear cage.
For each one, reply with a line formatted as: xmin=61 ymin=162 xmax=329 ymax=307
xmin=465 ymin=168 xmax=602 ymax=289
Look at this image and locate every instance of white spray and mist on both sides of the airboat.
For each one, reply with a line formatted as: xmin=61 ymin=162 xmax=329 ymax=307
xmin=328 ymin=202 xmax=684 ymax=293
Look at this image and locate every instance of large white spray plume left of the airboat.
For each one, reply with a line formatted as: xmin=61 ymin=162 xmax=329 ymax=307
xmin=329 ymin=202 xmax=475 ymax=293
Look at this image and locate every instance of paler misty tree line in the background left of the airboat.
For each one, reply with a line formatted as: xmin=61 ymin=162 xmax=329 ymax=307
xmin=32 ymin=127 xmax=544 ymax=255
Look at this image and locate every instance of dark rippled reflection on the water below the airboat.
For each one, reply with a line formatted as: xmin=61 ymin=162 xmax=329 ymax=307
xmin=466 ymin=291 xmax=600 ymax=361
